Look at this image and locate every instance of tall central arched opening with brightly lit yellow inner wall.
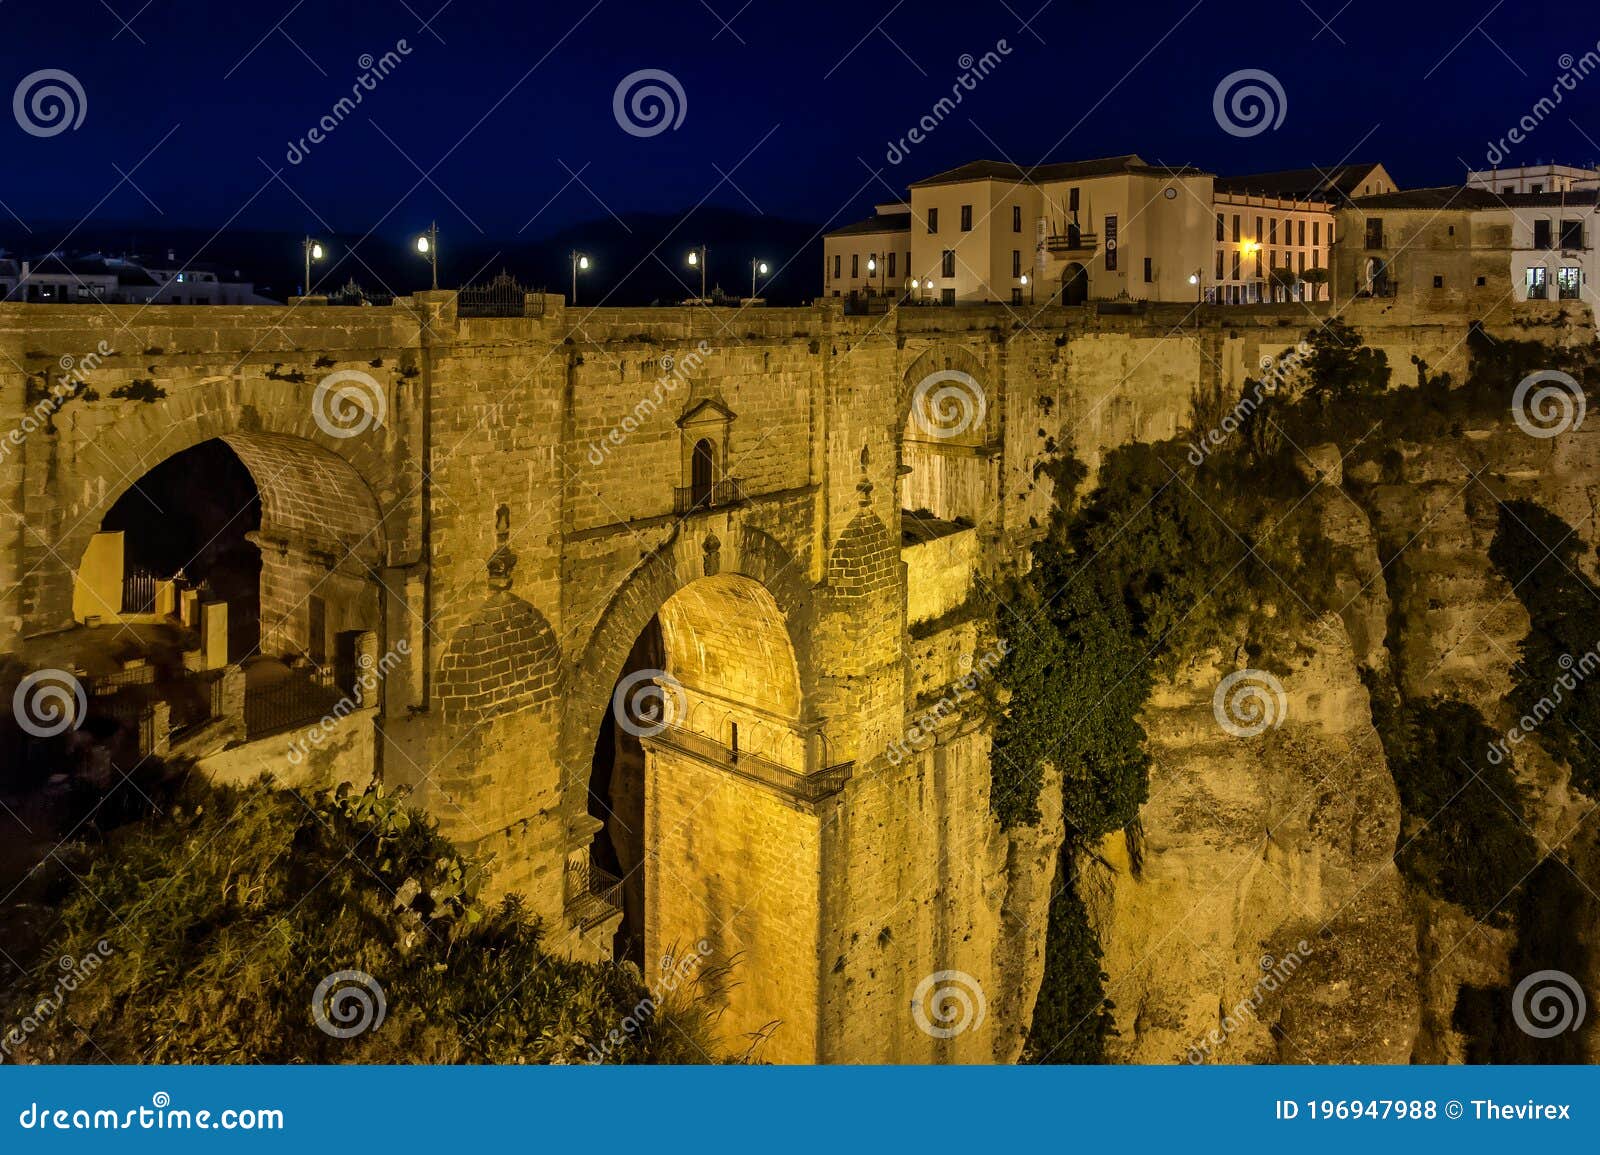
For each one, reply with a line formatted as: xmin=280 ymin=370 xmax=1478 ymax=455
xmin=589 ymin=573 xmax=814 ymax=1030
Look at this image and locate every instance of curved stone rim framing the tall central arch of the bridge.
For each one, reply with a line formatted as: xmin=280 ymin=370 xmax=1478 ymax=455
xmin=562 ymin=522 xmax=818 ymax=814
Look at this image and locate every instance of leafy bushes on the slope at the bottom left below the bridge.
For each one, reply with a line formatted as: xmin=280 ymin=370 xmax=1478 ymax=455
xmin=0 ymin=779 xmax=714 ymax=1062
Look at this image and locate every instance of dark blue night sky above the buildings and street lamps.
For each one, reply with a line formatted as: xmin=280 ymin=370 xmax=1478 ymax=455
xmin=0 ymin=0 xmax=1600 ymax=297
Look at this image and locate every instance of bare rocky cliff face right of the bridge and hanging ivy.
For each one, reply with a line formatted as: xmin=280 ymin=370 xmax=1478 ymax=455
xmin=1085 ymin=418 xmax=1600 ymax=1062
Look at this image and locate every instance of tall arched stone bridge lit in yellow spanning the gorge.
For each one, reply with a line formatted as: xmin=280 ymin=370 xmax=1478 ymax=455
xmin=0 ymin=293 xmax=1461 ymax=1062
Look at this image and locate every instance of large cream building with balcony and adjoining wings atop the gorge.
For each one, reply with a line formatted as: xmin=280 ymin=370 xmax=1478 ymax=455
xmin=824 ymin=154 xmax=1395 ymax=307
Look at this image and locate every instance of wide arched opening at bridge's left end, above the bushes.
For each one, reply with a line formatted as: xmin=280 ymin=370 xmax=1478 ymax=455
xmin=74 ymin=430 xmax=384 ymax=739
